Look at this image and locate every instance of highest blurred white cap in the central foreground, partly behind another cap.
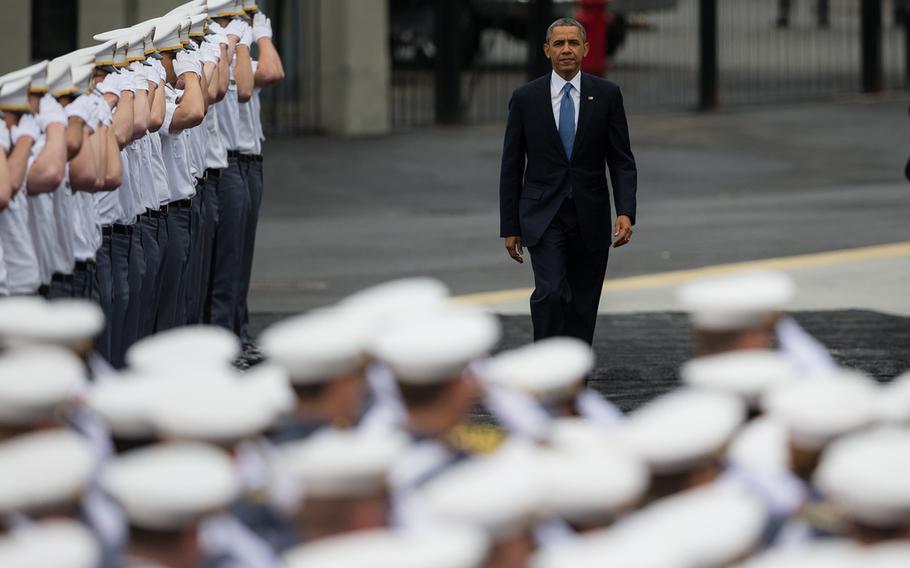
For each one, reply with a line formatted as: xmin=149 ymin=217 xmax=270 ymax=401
xmin=338 ymin=278 xmax=449 ymax=333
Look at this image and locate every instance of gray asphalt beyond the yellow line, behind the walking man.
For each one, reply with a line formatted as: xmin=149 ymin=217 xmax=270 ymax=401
xmin=250 ymin=98 xmax=910 ymax=312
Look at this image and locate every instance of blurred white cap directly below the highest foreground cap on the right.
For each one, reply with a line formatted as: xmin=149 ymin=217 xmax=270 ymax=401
xmin=679 ymin=350 xmax=800 ymax=406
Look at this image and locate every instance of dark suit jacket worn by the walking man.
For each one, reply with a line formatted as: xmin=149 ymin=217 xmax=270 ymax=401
xmin=499 ymin=73 xmax=637 ymax=250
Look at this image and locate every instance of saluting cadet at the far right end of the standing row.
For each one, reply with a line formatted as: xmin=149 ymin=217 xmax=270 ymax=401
xmin=237 ymin=8 xmax=284 ymax=345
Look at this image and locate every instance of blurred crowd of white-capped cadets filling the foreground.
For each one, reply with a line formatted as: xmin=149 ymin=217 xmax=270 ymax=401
xmin=0 ymin=273 xmax=910 ymax=568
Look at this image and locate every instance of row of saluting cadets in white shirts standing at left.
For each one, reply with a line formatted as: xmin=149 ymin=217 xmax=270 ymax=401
xmin=0 ymin=0 xmax=284 ymax=368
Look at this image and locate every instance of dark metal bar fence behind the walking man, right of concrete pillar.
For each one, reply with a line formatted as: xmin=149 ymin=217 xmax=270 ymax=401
xmin=390 ymin=0 xmax=910 ymax=128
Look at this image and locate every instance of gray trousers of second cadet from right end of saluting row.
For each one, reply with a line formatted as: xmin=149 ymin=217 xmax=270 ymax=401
xmin=210 ymin=155 xmax=250 ymax=333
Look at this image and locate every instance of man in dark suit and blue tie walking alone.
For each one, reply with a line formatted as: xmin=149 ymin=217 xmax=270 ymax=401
xmin=499 ymin=18 xmax=637 ymax=343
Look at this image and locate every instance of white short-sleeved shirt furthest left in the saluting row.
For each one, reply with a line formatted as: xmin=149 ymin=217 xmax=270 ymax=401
xmin=0 ymin=185 xmax=41 ymax=295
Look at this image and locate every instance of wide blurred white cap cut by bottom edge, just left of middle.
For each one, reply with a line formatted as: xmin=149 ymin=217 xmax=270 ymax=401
xmin=282 ymin=526 xmax=490 ymax=568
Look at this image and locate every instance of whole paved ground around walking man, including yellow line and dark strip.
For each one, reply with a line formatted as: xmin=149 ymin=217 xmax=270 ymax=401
xmin=250 ymin=98 xmax=910 ymax=408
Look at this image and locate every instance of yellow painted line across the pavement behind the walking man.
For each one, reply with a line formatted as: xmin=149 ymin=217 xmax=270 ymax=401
xmin=452 ymin=241 xmax=910 ymax=304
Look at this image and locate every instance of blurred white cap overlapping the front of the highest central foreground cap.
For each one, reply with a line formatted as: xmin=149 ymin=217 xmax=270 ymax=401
xmin=373 ymin=308 xmax=502 ymax=384
